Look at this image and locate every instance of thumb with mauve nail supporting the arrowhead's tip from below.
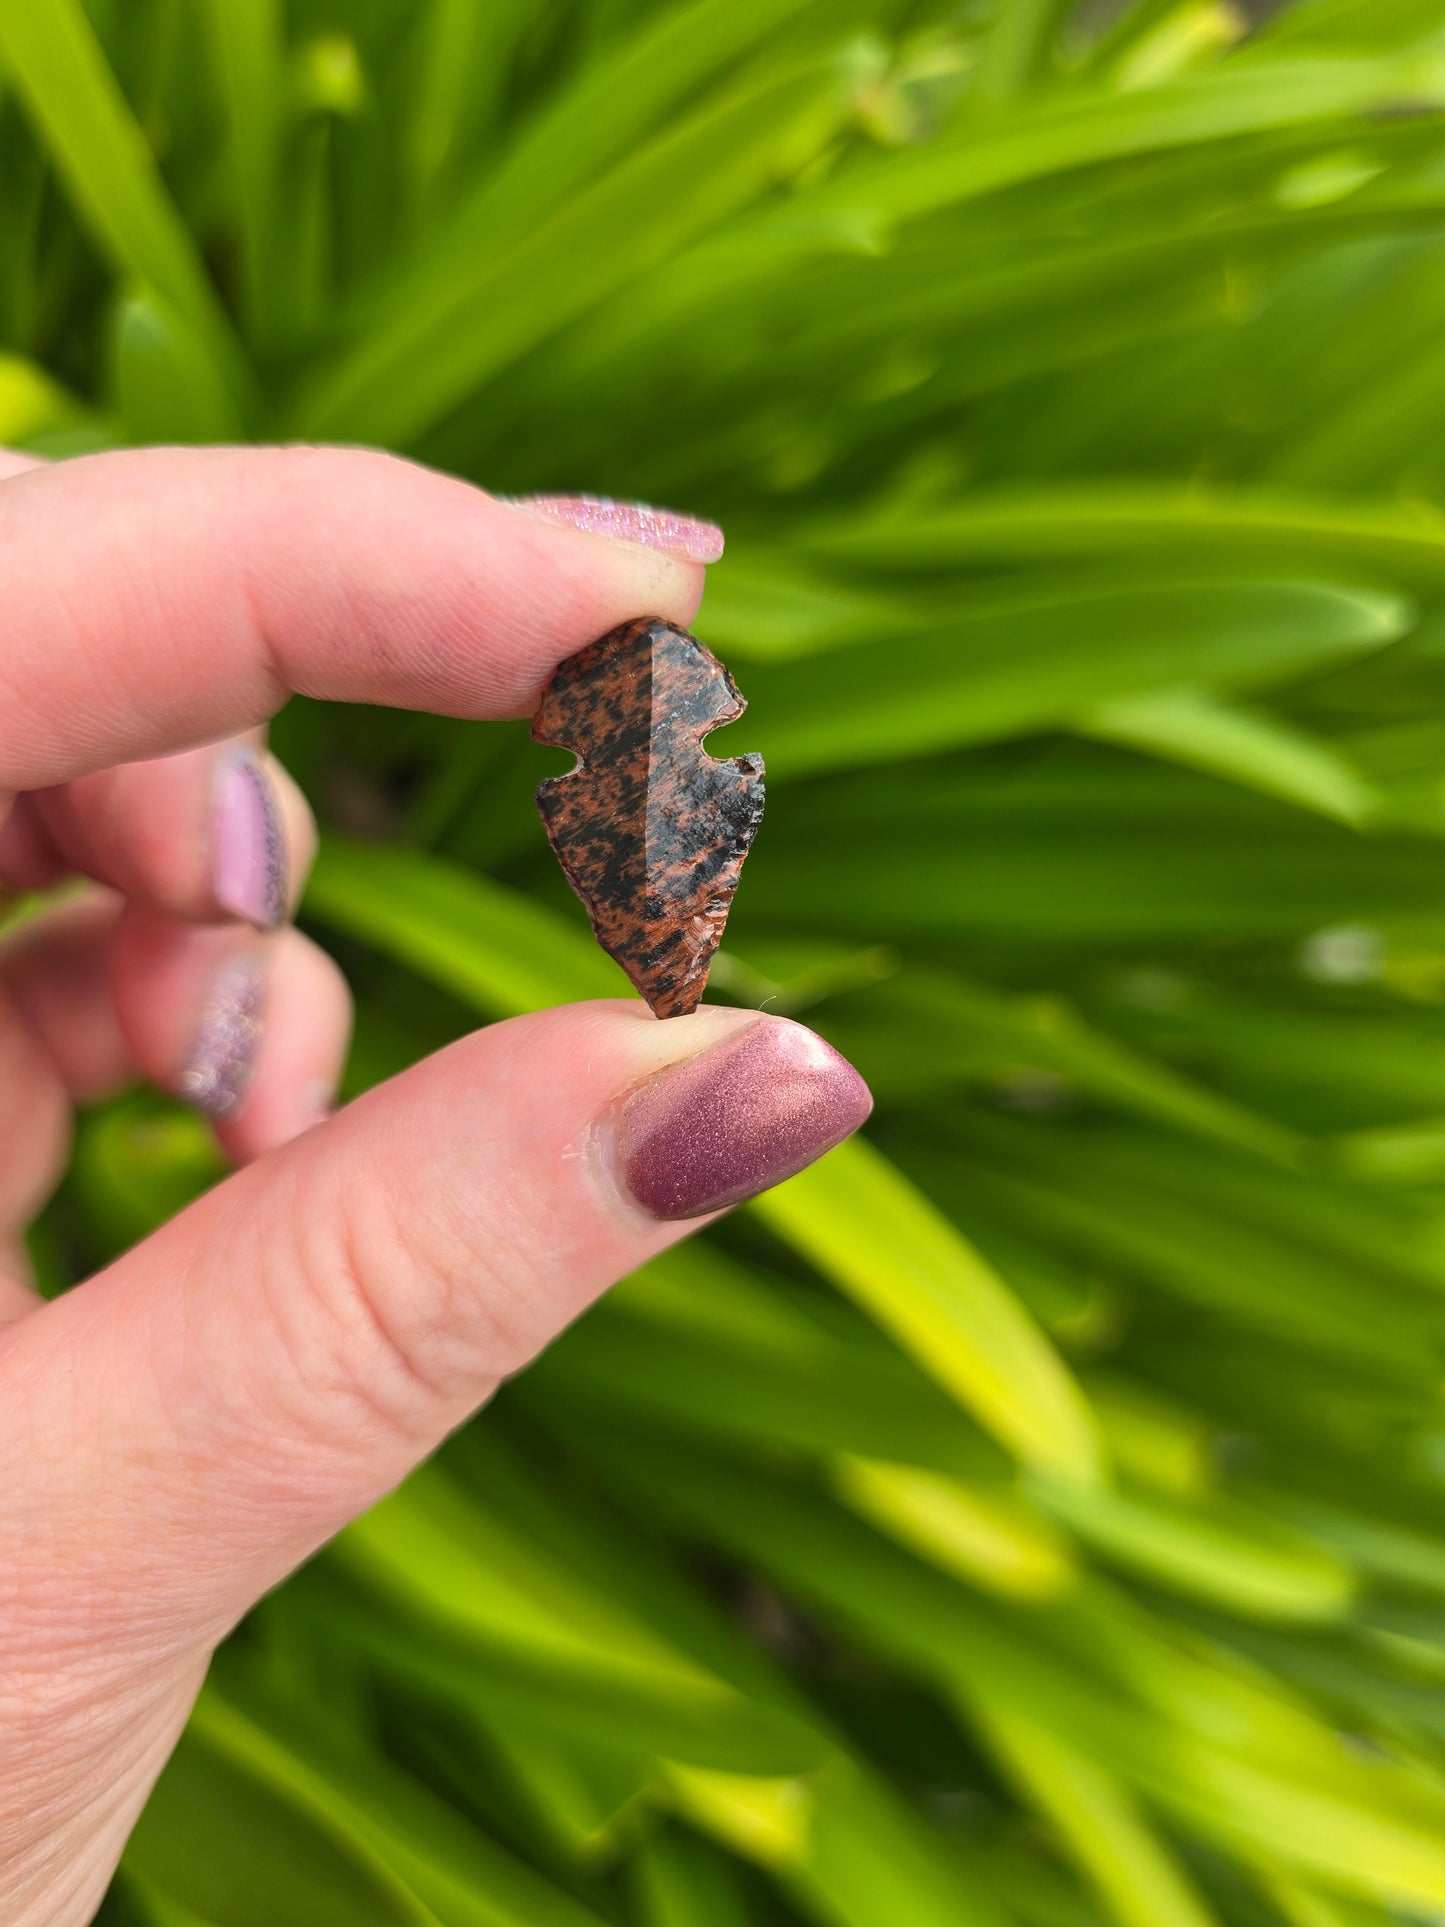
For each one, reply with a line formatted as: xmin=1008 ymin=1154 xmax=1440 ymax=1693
xmin=0 ymin=1004 xmax=871 ymax=1653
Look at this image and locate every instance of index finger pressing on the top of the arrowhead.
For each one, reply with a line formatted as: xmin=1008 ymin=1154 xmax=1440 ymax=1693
xmin=0 ymin=447 xmax=703 ymax=802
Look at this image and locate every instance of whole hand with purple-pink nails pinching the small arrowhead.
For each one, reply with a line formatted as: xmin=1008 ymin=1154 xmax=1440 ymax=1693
xmin=0 ymin=449 xmax=869 ymax=1927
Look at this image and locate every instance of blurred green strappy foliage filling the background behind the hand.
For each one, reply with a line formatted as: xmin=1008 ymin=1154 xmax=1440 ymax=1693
xmin=14 ymin=0 xmax=1445 ymax=1927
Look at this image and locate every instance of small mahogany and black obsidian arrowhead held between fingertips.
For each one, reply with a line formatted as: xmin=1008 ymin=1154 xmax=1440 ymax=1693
xmin=532 ymin=617 xmax=763 ymax=1017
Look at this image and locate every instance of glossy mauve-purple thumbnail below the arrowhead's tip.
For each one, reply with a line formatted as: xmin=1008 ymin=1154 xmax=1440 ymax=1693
xmin=615 ymin=1017 xmax=873 ymax=1220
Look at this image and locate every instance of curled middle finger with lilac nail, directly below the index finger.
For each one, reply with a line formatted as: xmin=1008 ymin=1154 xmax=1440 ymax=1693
xmin=15 ymin=734 xmax=316 ymax=929
